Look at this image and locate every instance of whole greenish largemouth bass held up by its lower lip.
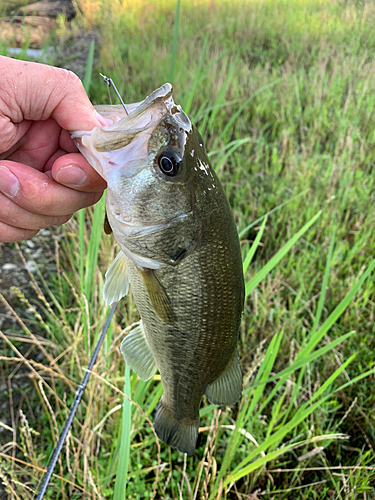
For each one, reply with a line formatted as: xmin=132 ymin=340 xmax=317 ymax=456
xmin=71 ymin=83 xmax=244 ymax=455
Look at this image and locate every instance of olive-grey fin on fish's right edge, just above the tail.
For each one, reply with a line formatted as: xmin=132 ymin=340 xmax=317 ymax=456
xmin=206 ymin=350 xmax=242 ymax=406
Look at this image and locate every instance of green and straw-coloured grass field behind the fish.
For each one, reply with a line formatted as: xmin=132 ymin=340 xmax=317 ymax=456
xmin=0 ymin=0 xmax=375 ymax=500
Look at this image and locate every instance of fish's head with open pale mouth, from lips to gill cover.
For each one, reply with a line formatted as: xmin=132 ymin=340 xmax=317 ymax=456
xmin=72 ymin=83 xmax=226 ymax=268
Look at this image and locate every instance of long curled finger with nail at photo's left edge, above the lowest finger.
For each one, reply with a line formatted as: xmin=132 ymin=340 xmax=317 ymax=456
xmin=0 ymin=160 xmax=102 ymax=216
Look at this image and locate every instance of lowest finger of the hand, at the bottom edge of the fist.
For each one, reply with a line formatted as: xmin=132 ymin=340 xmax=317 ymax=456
xmin=0 ymin=193 xmax=72 ymax=231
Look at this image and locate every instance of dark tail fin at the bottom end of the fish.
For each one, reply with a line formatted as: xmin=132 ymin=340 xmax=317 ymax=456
xmin=154 ymin=398 xmax=199 ymax=455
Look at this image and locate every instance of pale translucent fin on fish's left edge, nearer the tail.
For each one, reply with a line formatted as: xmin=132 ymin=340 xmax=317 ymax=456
xmin=120 ymin=322 xmax=156 ymax=380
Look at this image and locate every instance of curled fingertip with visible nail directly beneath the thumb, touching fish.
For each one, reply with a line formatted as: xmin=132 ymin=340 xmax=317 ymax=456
xmin=52 ymin=153 xmax=107 ymax=192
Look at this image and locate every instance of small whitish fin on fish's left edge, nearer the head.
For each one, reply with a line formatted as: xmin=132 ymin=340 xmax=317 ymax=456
xmin=103 ymin=252 xmax=129 ymax=306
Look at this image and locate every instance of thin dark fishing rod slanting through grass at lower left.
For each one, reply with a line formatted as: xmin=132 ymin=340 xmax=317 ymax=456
xmin=36 ymin=302 xmax=117 ymax=500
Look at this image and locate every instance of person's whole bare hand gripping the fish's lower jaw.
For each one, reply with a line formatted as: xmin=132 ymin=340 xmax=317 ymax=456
xmin=0 ymin=56 xmax=106 ymax=242
